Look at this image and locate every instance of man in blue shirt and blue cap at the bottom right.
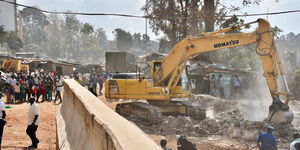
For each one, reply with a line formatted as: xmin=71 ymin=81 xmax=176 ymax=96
xmin=257 ymin=126 xmax=277 ymax=150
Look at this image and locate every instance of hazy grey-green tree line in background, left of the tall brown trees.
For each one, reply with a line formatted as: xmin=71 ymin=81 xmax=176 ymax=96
xmin=18 ymin=8 xmax=157 ymax=63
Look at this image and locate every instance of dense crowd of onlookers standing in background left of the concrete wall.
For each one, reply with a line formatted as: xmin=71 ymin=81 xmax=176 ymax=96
xmin=0 ymin=70 xmax=63 ymax=104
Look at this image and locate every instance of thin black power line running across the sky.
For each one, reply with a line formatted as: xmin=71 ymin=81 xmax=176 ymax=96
xmin=0 ymin=0 xmax=300 ymax=19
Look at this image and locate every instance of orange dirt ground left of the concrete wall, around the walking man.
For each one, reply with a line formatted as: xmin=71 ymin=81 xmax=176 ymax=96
xmin=2 ymin=102 xmax=60 ymax=150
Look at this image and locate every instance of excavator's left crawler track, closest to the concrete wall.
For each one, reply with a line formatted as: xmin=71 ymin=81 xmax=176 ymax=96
xmin=116 ymin=102 xmax=162 ymax=124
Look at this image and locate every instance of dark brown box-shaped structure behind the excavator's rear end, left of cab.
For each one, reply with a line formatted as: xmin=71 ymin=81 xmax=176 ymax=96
xmin=105 ymin=52 xmax=136 ymax=72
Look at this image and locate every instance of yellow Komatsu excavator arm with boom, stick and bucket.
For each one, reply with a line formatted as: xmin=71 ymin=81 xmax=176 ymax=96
xmin=153 ymin=19 xmax=293 ymax=122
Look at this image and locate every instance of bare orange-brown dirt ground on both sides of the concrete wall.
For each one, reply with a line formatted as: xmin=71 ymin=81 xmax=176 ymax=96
xmin=2 ymin=92 xmax=300 ymax=150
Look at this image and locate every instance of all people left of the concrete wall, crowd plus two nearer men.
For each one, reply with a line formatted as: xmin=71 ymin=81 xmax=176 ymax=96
xmin=0 ymin=70 xmax=63 ymax=149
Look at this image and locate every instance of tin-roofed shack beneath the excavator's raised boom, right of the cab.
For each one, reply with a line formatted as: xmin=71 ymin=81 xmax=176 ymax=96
xmin=187 ymin=55 xmax=258 ymax=99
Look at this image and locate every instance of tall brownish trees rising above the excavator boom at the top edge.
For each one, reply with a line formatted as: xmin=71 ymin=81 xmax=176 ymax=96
xmin=142 ymin=0 xmax=226 ymax=46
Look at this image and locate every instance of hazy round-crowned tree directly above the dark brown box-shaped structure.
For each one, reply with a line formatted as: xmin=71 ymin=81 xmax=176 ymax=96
xmin=113 ymin=28 xmax=133 ymax=51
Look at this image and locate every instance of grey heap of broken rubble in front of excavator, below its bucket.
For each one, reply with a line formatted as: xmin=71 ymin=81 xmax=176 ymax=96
xmin=124 ymin=95 xmax=299 ymax=149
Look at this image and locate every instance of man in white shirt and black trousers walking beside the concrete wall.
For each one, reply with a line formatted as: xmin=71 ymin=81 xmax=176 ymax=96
xmin=26 ymin=98 xmax=41 ymax=148
